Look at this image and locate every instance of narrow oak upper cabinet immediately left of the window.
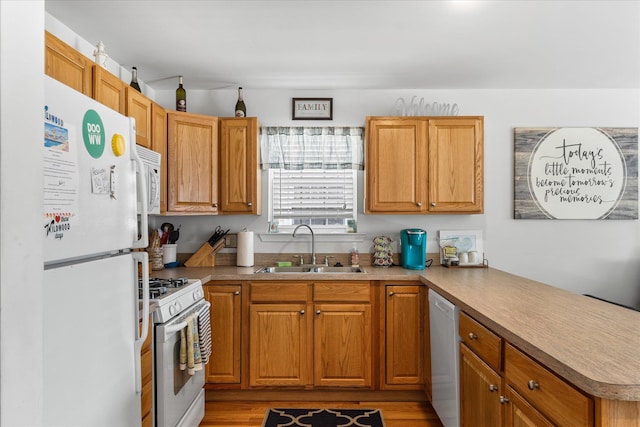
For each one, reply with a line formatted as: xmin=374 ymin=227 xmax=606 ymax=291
xmin=220 ymin=117 xmax=262 ymax=215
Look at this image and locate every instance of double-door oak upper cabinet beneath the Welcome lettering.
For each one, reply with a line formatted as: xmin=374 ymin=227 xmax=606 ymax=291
xmin=365 ymin=117 xmax=484 ymax=214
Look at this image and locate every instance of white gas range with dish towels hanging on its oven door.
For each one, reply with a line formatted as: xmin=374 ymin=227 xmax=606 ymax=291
xmin=140 ymin=278 xmax=210 ymax=427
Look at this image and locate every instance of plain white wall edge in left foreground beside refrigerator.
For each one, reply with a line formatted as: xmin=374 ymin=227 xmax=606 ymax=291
xmin=0 ymin=0 xmax=44 ymax=427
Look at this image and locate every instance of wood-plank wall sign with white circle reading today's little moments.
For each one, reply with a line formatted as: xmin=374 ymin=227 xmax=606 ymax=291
xmin=514 ymin=128 xmax=638 ymax=219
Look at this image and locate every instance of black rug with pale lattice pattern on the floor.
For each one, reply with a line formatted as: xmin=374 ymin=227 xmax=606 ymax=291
xmin=262 ymin=408 xmax=384 ymax=427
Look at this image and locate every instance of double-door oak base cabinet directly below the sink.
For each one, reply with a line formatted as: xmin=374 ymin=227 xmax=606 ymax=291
xmin=249 ymin=282 xmax=373 ymax=388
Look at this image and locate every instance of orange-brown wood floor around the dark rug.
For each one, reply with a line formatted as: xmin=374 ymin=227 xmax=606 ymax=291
xmin=200 ymin=390 xmax=442 ymax=427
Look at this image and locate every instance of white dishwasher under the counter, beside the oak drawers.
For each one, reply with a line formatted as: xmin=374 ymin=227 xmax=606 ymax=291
xmin=429 ymin=289 xmax=460 ymax=427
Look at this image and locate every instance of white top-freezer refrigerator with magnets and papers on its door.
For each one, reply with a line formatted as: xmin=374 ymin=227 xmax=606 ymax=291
xmin=42 ymin=76 xmax=149 ymax=427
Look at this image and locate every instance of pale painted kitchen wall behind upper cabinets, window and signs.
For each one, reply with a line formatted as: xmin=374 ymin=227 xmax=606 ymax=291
xmin=46 ymin=16 xmax=640 ymax=306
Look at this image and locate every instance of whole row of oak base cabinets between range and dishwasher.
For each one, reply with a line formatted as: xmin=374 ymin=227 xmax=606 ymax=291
xmin=205 ymin=280 xmax=430 ymax=395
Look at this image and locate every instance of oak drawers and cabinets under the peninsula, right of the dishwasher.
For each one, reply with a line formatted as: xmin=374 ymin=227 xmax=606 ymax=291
xmin=459 ymin=312 xmax=596 ymax=427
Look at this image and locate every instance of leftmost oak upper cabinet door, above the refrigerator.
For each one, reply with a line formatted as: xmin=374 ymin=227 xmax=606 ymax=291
xmin=44 ymin=31 xmax=94 ymax=96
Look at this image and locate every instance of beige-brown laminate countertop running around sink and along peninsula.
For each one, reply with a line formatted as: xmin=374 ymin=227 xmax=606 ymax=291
xmin=151 ymin=266 xmax=640 ymax=401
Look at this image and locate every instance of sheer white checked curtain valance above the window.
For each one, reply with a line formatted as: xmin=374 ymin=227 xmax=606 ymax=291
xmin=260 ymin=126 xmax=364 ymax=170
